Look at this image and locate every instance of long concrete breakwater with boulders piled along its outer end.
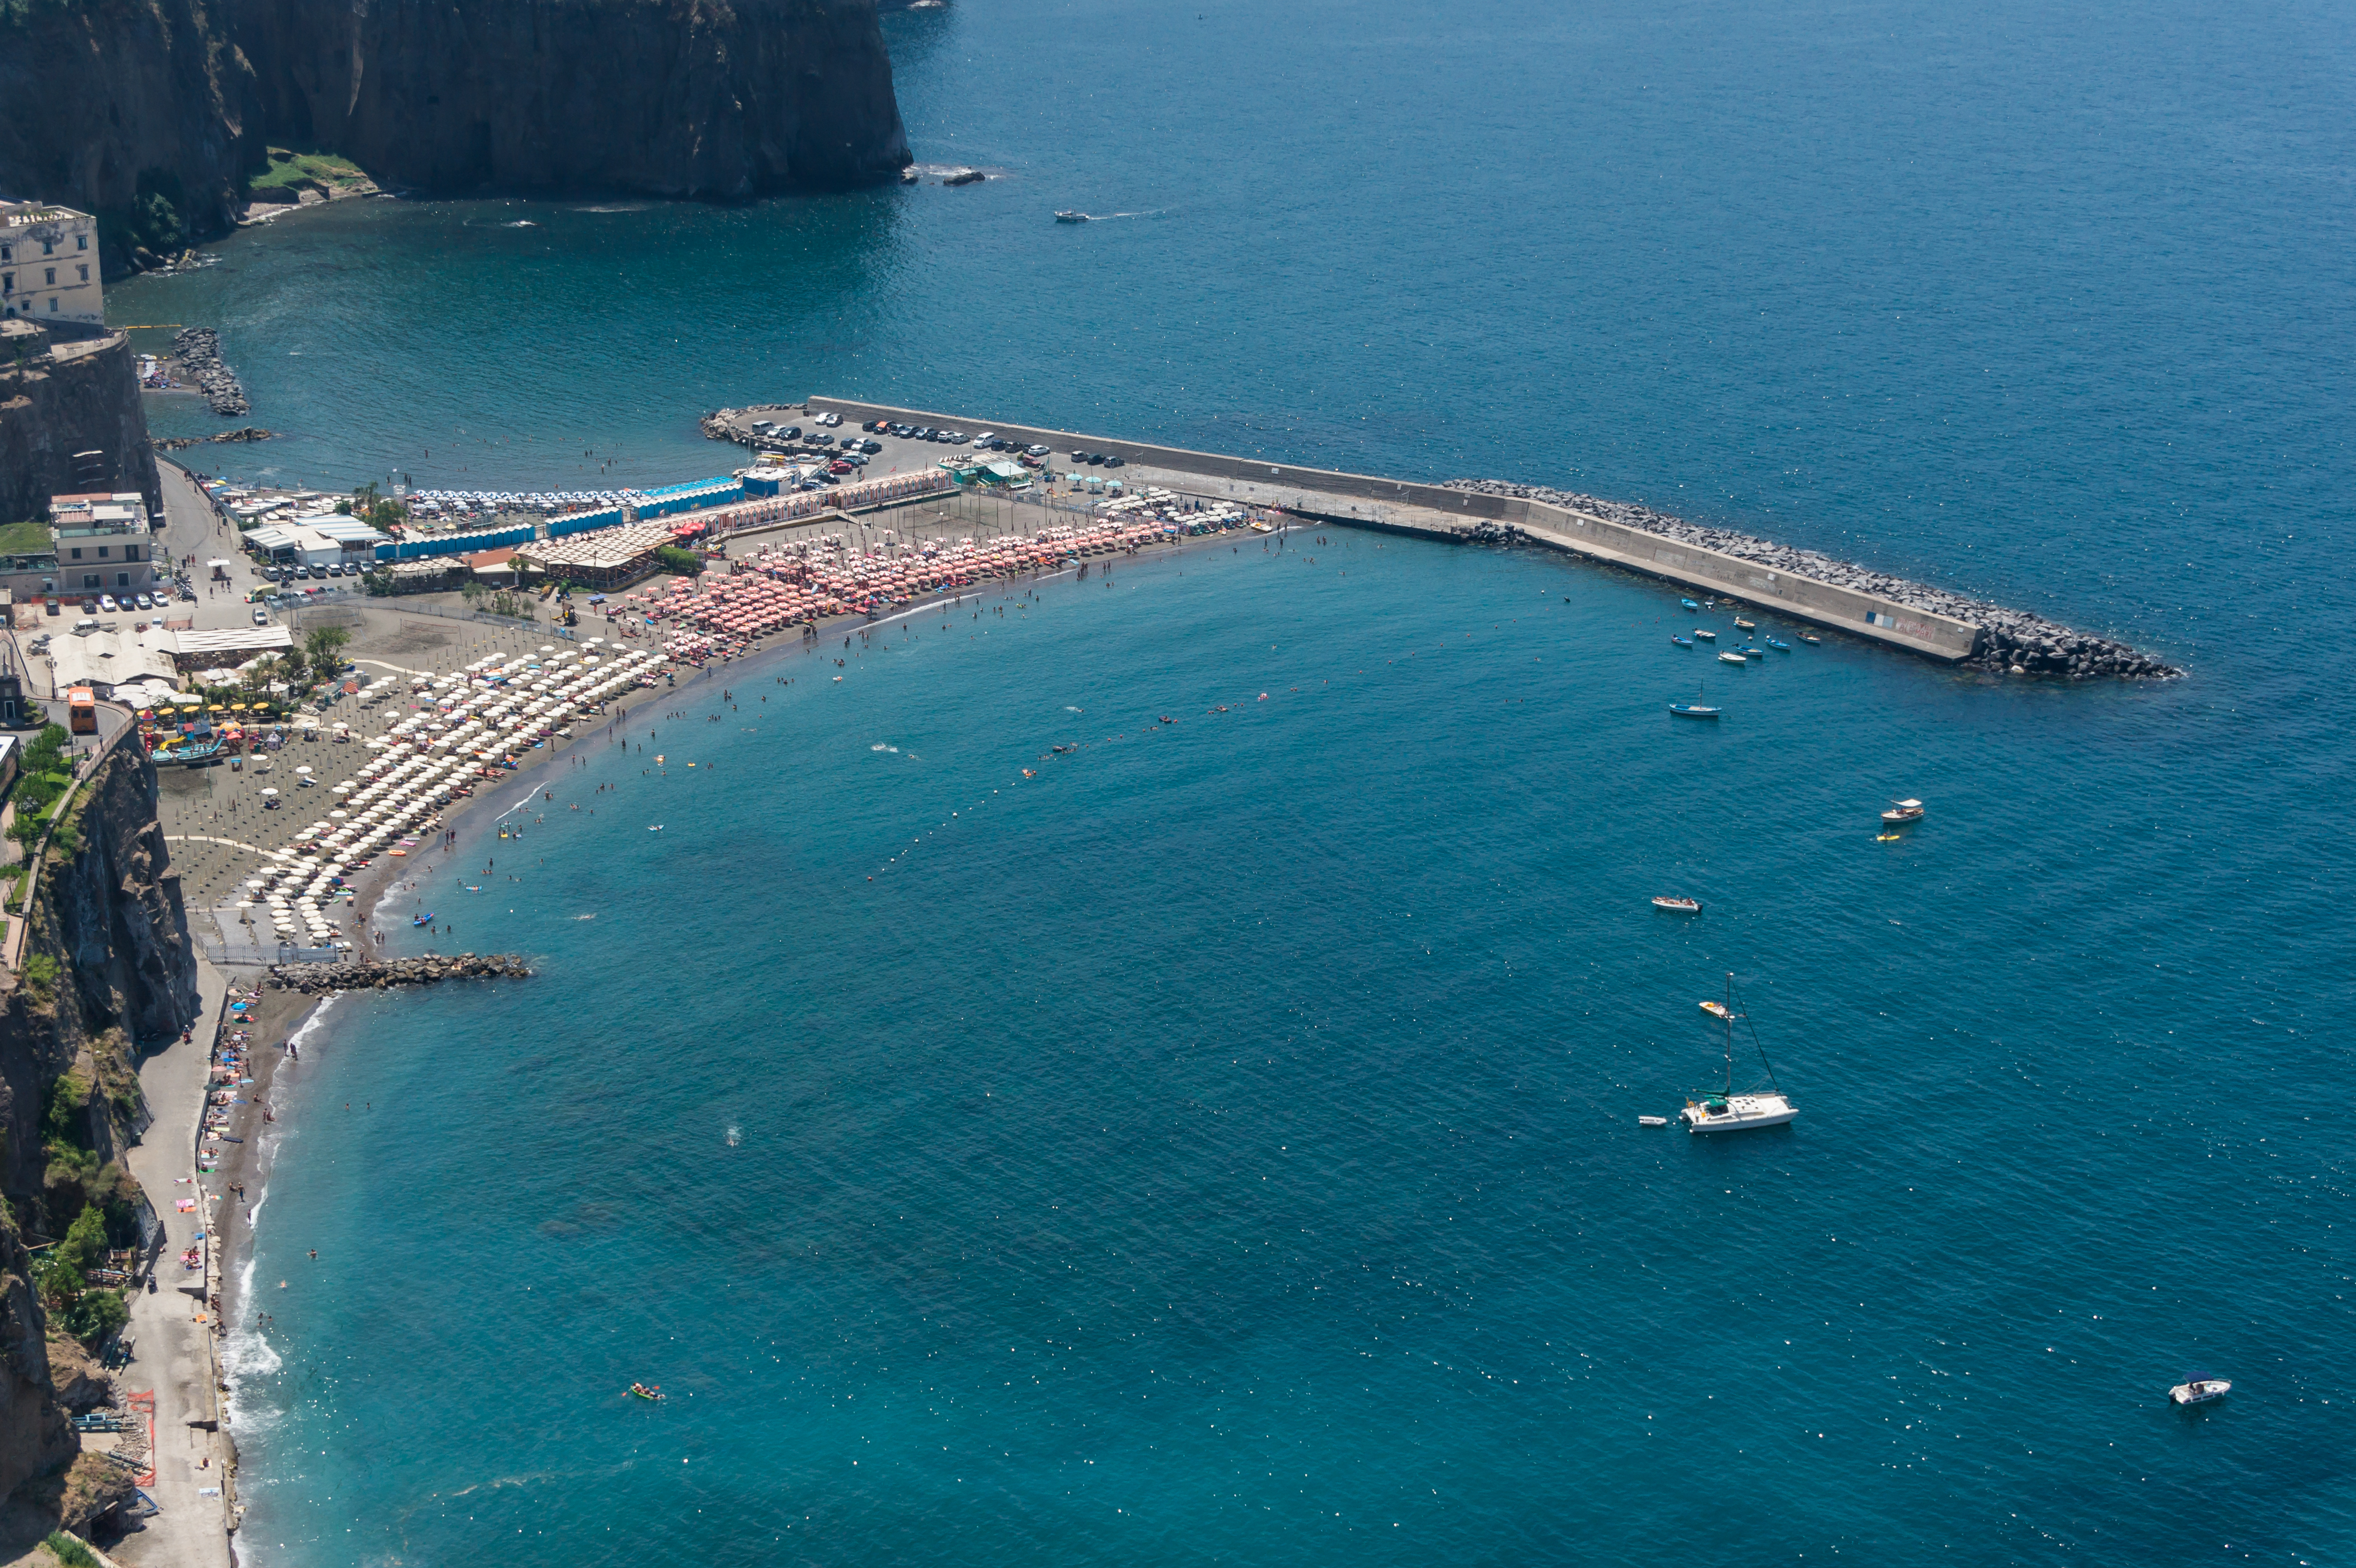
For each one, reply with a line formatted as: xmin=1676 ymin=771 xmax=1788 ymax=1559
xmin=801 ymin=398 xmax=2182 ymax=678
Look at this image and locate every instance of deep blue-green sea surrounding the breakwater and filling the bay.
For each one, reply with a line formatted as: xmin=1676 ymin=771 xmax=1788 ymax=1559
xmin=111 ymin=0 xmax=2356 ymax=1568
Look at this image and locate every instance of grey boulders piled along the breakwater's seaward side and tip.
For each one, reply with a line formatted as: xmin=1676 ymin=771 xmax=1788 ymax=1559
xmin=1449 ymin=480 xmax=2184 ymax=680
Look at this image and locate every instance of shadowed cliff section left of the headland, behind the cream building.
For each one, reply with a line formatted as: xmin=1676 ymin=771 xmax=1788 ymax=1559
xmin=0 ymin=0 xmax=259 ymax=233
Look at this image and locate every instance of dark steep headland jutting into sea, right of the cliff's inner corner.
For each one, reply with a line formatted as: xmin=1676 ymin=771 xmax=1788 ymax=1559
xmin=238 ymin=0 xmax=910 ymax=200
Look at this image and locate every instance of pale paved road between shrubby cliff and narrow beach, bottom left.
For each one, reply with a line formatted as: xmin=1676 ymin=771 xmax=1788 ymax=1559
xmin=111 ymin=958 xmax=228 ymax=1568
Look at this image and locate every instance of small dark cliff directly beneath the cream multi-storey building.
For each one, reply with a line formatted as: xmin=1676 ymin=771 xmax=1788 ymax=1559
xmin=0 ymin=332 xmax=163 ymax=523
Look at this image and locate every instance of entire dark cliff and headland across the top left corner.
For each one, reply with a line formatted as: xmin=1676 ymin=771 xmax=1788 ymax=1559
xmin=0 ymin=0 xmax=910 ymax=271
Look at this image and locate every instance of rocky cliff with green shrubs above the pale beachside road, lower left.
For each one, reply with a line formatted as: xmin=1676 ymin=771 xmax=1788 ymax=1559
xmin=0 ymin=747 xmax=198 ymax=1495
